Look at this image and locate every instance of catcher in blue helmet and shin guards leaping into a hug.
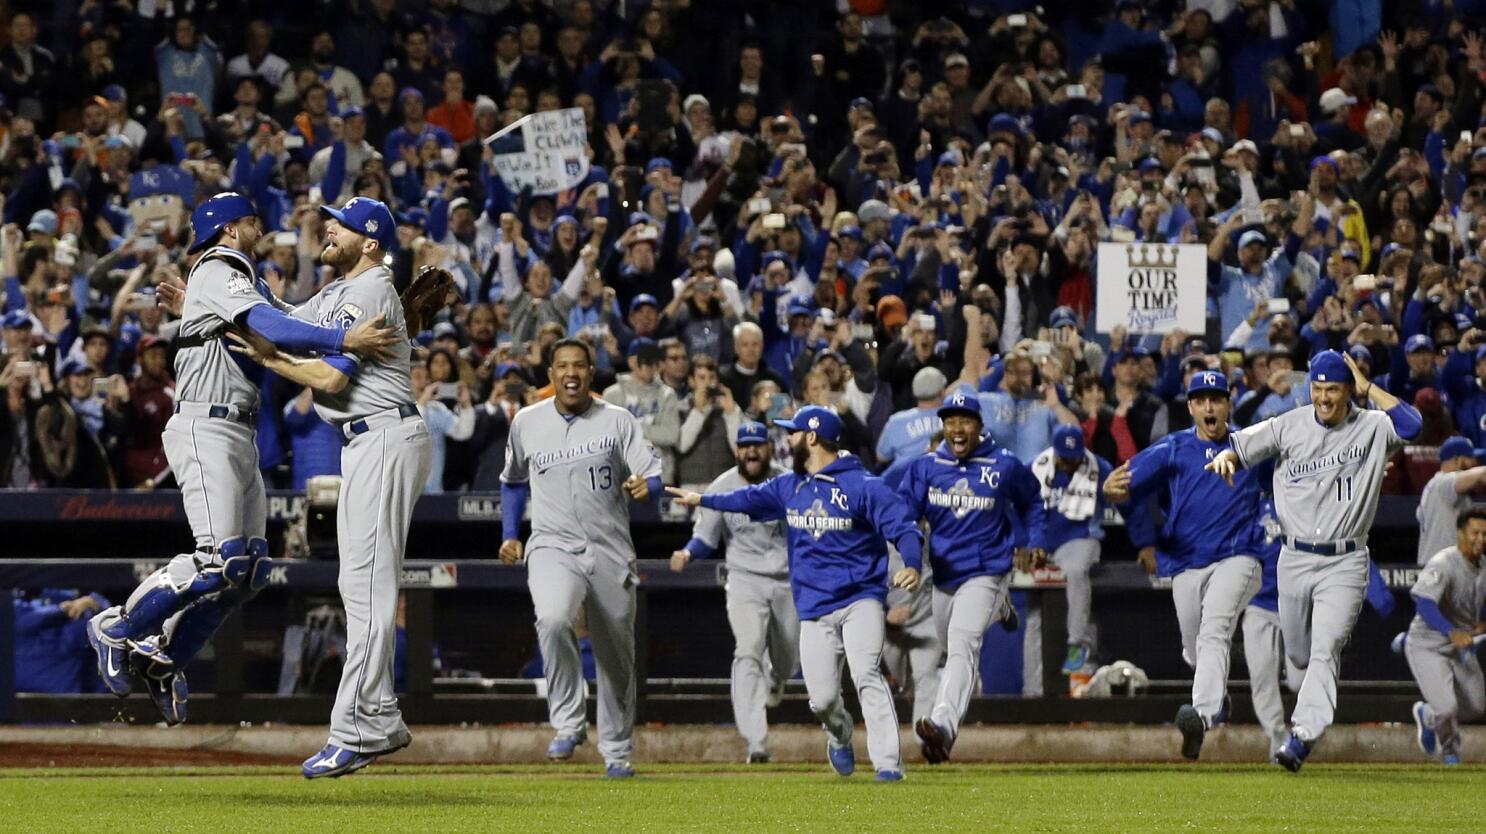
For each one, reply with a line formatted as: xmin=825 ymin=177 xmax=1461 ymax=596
xmin=88 ymin=192 xmax=395 ymax=724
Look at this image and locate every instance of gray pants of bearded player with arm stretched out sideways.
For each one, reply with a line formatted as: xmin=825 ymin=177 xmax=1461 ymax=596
xmin=799 ymin=599 xmax=902 ymax=770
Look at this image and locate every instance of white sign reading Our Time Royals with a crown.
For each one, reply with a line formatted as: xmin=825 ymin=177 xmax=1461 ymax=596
xmin=1095 ymin=242 xmax=1207 ymax=333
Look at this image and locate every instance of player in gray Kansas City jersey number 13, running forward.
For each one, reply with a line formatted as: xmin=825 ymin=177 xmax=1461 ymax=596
xmin=501 ymin=339 xmax=661 ymax=779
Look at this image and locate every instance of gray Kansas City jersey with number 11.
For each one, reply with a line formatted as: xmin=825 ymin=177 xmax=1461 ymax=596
xmin=1232 ymin=407 xmax=1406 ymax=541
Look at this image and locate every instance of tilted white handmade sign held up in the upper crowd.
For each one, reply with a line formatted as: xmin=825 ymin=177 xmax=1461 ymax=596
xmin=484 ymin=107 xmax=588 ymax=195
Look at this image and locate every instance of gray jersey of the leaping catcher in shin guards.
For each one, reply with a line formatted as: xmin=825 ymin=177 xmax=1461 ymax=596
xmin=175 ymin=247 xmax=269 ymax=410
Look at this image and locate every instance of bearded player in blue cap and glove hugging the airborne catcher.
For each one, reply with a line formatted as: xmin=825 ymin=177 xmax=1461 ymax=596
xmin=233 ymin=198 xmax=432 ymax=779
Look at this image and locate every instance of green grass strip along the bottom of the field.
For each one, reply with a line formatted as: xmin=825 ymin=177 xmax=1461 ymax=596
xmin=0 ymin=764 xmax=1486 ymax=834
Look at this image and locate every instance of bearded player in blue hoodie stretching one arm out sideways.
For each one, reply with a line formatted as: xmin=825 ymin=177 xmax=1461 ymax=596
xmin=669 ymin=406 xmax=923 ymax=782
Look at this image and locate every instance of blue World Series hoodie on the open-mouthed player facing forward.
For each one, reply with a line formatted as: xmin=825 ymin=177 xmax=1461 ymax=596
xmin=898 ymin=436 xmax=1043 ymax=590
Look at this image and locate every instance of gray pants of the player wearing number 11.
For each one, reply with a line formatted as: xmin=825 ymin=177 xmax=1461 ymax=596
xmin=1278 ymin=546 xmax=1367 ymax=742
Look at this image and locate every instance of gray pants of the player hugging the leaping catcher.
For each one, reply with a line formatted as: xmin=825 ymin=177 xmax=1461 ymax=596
xmin=320 ymin=418 xmax=432 ymax=752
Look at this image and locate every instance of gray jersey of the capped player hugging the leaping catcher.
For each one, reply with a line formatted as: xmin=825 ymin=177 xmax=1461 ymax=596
xmin=294 ymin=266 xmax=413 ymax=425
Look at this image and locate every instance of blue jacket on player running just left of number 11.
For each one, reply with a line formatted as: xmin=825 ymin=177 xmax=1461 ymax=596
xmin=1119 ymin=428 xmax=1265 ymax=577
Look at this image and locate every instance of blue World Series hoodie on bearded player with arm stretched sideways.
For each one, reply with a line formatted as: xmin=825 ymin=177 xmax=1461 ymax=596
xmin=701 ymin=455 xmax=923 ymax=620
